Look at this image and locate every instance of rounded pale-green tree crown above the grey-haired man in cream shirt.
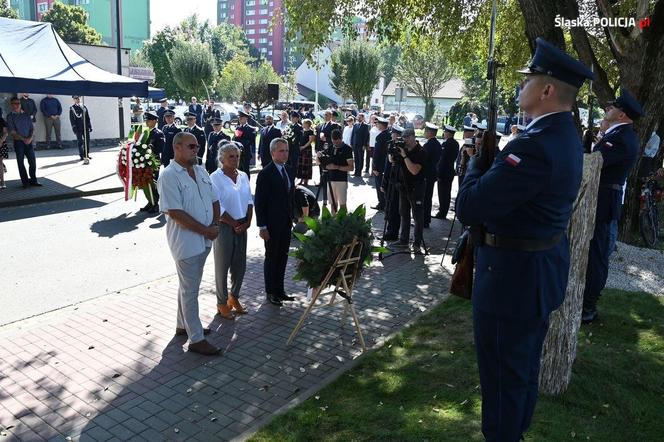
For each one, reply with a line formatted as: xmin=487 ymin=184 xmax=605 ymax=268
xmin=170 ymin=40 xmax=216 ymax=96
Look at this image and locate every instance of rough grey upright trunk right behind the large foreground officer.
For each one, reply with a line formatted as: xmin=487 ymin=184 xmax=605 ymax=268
xmin=539 ymin=152 xmax=602 ymax=395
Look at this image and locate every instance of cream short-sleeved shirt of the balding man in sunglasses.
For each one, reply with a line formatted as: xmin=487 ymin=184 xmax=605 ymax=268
xmin=157 ymin=161 xmax=217 ymax=261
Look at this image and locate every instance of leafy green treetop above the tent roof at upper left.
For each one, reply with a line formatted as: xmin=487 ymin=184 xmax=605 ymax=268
xmin=42 ymin=2 xmax=102 ymax=45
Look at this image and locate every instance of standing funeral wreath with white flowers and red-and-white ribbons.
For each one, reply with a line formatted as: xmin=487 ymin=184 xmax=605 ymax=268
xmin=117 ymin=125 xmax=161 ymax=204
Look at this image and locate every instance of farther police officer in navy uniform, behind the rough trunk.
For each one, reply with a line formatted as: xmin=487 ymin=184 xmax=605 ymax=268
xmin=581 ymin=88 xmax=643 ymax=324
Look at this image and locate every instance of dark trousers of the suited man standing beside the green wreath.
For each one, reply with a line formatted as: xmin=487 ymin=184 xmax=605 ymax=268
xmin=263 ymin=223 xmax=291 ymax=295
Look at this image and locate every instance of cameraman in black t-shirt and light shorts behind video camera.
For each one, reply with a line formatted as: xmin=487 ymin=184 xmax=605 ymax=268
xmin=325 ymin=129 xmax=355 ymax=213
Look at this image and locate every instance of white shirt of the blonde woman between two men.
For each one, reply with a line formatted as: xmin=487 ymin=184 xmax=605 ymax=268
xmin=210 ymin=169 xmax=254 ymax=220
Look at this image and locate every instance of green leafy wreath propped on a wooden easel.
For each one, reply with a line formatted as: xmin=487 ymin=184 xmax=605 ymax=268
xmin=290 ymin=205 xmax=383 ymax=287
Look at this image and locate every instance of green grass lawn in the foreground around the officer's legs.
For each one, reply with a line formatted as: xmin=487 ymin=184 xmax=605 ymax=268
xmin=250 ymin=290 xmax=664 ymax=442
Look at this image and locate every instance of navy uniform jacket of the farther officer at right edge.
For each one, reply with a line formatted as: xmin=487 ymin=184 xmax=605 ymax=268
xmin=593 ymin=124 xmax=639 ymax=222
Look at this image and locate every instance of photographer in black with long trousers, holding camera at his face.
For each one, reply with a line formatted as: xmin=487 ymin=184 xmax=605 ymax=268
xmin=389 ymin=129 xmax=427 ymax=254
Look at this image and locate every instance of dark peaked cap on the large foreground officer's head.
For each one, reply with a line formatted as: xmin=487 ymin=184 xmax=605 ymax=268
xmin=517 ymin=37 xmax=595 ymax=89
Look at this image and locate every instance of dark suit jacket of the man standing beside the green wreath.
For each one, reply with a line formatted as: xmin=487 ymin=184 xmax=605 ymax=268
xmin=254 ymin=162 xmax=295 ymax=231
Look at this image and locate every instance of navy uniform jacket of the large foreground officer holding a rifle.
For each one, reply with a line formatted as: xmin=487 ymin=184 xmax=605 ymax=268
xmin=456 ymin=112 xmax=583 ymax=320
